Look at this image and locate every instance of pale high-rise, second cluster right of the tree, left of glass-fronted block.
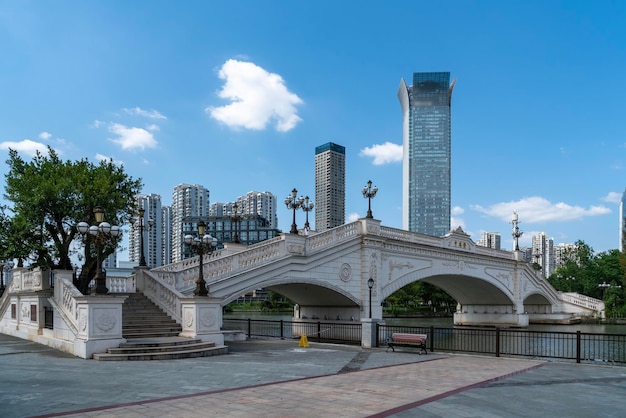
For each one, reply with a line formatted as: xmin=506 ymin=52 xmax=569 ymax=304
xmin=172 ymin=183 xmax=209 ymax=262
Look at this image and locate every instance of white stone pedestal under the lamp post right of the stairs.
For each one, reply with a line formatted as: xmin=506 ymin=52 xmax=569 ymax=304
xmin=180 ymin=297 xmax=224 ymax=345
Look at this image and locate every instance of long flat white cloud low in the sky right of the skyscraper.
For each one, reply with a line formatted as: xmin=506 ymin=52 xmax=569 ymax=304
xmin=470 ymin=196 xmax=611 ymax=223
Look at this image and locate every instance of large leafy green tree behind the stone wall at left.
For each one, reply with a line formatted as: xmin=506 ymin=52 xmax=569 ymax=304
xmin=5 ymin=147 xmax=141 ymax=291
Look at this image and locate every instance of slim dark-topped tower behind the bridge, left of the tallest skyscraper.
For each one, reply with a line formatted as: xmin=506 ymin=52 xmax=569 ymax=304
xmin=313 ymin=142 xmax=346 ymax=231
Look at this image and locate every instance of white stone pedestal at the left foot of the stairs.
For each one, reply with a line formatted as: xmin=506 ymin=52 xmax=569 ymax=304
xmin=74 ymin=295 xmax=128 ymax=358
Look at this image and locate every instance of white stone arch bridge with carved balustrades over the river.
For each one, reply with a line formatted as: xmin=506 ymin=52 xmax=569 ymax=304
xmin=144 ymin=218 xmax=603 ymax=327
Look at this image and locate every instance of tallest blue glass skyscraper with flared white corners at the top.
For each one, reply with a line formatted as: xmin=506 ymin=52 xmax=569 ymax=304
xmin=398 ymin=72 xmax=456 ymax=237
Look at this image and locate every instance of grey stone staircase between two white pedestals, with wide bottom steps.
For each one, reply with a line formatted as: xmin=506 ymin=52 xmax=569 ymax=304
xmin=93 ymin=293 xmax=228 ymax=361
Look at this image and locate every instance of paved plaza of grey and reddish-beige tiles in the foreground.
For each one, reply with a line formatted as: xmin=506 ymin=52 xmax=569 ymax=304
xmin=0 ymin=334 xmax=626 ymax=418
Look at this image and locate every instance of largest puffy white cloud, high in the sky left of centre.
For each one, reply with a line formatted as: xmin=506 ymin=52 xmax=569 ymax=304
xmin=205 ymin=59 xmax=303 ymax=132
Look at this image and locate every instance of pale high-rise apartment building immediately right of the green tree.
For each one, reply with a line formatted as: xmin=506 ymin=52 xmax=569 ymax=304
xmin=128 ymin=193 xmax=165 ymax=267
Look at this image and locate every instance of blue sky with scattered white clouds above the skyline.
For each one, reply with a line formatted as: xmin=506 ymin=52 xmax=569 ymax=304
xmin=0 ymin=0 xmax=626 ymax=258
